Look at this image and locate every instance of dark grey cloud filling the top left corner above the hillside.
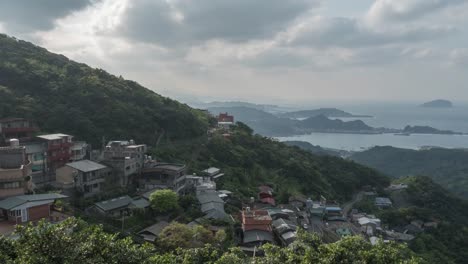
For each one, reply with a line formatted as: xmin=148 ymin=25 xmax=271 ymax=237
xmin=0 ymin=0 xmax=91 ymax=33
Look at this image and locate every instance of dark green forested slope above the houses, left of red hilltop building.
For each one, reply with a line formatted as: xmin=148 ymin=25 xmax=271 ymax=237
xmin=0 ymin=34 xmax=208 ymax=144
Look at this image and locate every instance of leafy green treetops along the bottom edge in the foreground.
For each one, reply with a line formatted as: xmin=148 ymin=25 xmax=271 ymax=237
xmin=0 ymin=218 xmax=420 ymax=264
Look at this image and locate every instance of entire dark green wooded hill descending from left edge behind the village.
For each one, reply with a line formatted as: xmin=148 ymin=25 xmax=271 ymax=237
xmin=0 ymin=35 xmax=389 ymax=200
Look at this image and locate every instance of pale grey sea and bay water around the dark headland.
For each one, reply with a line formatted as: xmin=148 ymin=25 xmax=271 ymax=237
xmin=278 ymin=103 xmax=468 ymax=151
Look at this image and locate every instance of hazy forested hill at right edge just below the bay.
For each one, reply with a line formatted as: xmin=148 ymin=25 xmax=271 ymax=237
xmin=351 ymin=147 xmax=468 ymax=198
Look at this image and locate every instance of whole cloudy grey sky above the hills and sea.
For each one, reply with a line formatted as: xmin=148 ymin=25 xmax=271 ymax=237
xmin=0 ymin=0 xmax=468 ymax=104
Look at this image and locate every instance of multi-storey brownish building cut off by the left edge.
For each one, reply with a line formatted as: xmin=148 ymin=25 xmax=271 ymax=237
xmin=0 ymin=139 xmax=32 ymax=198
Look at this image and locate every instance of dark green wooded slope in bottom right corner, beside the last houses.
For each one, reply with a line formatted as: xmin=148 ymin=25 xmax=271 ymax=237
xmin=378 ymin=177 xmax=468 ymax=264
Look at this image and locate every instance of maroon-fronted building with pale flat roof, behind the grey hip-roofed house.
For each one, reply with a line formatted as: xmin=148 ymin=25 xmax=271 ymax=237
xmin=36 ymin=133 xmax=73 ymax=171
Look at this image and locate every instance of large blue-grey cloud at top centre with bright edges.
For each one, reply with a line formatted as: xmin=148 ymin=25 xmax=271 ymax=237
xmin=118 ymin=0 xmax=318 ymax=45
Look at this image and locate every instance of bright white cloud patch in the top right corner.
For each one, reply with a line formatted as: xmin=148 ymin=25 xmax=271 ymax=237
xmin=365 ymin=0 xmax=467 ymax=24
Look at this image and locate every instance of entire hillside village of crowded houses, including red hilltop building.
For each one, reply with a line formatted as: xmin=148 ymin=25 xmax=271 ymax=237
xmin=0 ymin=113 xmax=438 ymax=255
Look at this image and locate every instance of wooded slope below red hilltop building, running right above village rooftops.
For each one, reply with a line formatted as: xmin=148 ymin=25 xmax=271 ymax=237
xmin=155 ymin=123 xmax=389 ymax=201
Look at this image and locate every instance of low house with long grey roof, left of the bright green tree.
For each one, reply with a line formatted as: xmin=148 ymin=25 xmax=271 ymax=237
xmin=94 ymin=195 xmax=150 ymax=217
